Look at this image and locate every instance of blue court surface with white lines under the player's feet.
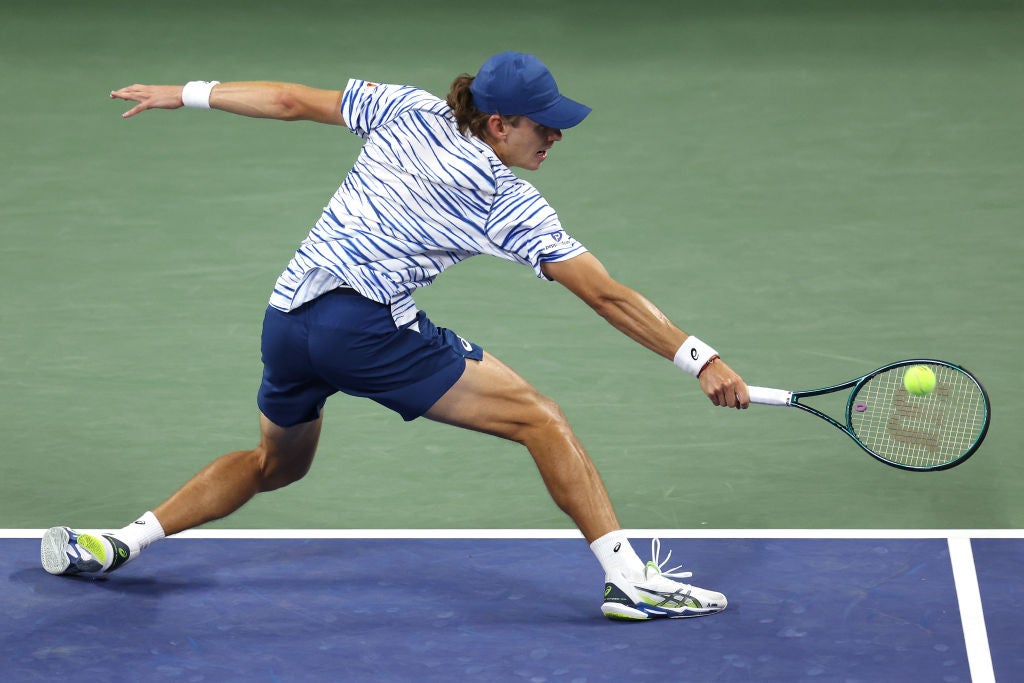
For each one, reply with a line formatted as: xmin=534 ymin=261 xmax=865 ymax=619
xmin=0 ymin=530 xmax=1024 ymax=683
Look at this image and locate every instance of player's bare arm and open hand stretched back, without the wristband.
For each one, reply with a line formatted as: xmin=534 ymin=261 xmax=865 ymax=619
xmin=111 ymin=81 xmax=345 ymax=126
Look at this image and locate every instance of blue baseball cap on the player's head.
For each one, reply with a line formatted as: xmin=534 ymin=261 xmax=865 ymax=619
xmin=469 ymin=52 xmax=591 ymax=128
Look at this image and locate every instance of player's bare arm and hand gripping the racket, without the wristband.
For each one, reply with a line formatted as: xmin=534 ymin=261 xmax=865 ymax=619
xmin=542 ymin=253 xmax=750 ymax=408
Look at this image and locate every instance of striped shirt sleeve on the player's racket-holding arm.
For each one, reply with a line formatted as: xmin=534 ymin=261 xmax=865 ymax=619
xmin=487 ymin=180 xmax=587 ymax=280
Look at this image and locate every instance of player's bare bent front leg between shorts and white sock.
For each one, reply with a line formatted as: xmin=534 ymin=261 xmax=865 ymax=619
xmin=426 ymin=352 xmax=620 ymax=543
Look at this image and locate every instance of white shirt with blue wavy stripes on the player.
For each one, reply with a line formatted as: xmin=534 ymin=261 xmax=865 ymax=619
xmin=270 ymin=79 xmax=587 ymax=326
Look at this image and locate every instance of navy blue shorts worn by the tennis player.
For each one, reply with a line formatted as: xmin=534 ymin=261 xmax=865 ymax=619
xmin=257 ymin=289 xmax=483 ymax=427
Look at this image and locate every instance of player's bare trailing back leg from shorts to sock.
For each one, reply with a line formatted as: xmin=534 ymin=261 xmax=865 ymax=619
xmin=153 ymin=414 xmax=324 ymax=536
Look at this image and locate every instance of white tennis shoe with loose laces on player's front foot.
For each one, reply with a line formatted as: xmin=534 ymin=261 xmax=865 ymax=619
xmin=601 ymin=539 xmax=729 ymax=622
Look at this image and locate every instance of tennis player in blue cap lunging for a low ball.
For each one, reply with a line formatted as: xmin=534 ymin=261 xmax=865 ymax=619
xmin=41 ymin=52 xmax=749 ymax=620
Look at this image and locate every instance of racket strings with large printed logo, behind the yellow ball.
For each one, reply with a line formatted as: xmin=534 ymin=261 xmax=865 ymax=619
xmin=850 ymin=364 xmax=988 ymax=468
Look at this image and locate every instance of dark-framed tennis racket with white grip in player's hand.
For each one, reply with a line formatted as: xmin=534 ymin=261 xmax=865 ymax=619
xmin=748 ymin=358 xmax=992 ymax=472
